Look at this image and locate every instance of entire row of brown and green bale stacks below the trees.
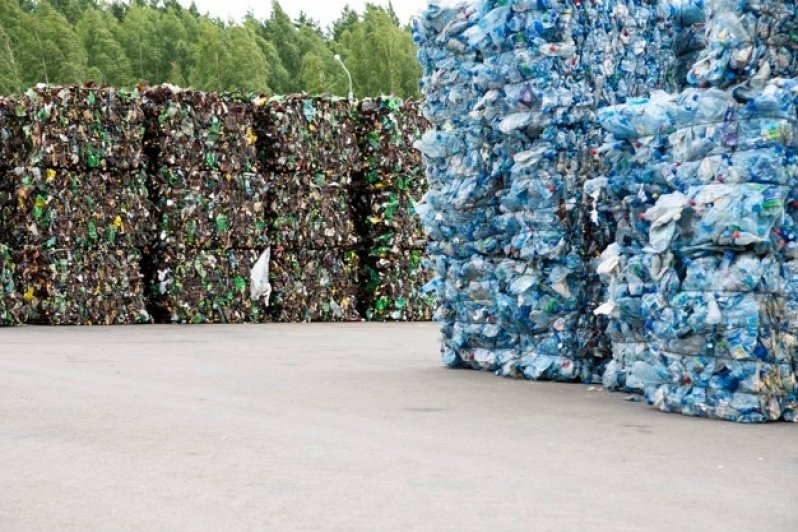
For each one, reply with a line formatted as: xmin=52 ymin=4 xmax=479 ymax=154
xmin=0 ymin=85 xmax=431 ymax=325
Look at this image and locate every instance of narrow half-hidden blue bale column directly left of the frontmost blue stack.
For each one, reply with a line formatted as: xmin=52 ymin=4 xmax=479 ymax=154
xmin=596 ymin=93 xmax=707 ymax=392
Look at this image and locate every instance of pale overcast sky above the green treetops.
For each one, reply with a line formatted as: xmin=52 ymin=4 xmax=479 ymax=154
xmin=181 ymin=0 xmax=427 ymax=28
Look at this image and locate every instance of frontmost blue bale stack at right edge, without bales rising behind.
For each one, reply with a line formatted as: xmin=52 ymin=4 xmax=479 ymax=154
xmin=605 ymin=80 xmax=798 ymax=422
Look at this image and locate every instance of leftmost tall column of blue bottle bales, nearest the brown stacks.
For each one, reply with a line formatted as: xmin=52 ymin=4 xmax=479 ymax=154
xmin=413 ymin=2 xmax=510 ymax=370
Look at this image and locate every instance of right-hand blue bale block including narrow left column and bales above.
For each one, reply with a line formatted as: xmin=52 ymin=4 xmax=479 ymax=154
xmin=599 ymin=0 xmax=798 ymax=422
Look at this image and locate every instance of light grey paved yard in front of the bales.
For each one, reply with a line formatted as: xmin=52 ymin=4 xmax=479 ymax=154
xmin=0 ymin=324 xmax=798 ymax=532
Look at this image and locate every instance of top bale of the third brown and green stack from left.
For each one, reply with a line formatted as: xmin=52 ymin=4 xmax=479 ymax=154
xmin=254 ymin=94 xmax=360 ymax=174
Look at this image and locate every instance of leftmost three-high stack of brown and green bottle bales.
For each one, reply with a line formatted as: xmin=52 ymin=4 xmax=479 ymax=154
xmin=0 ymin=85 xmax=151 ymax=325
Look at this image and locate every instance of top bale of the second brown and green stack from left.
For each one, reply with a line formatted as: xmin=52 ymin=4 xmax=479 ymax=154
xmin=142 ymin=85 xmax=257 ymax=173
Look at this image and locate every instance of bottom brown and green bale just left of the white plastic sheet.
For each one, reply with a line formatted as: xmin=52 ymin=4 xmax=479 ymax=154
xmin=147 ymin=246 xmax=270 ymax=324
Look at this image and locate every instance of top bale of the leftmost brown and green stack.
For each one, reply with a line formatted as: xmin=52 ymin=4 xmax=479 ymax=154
xmin=9 ymin=85 xmax=145 ymax=170
